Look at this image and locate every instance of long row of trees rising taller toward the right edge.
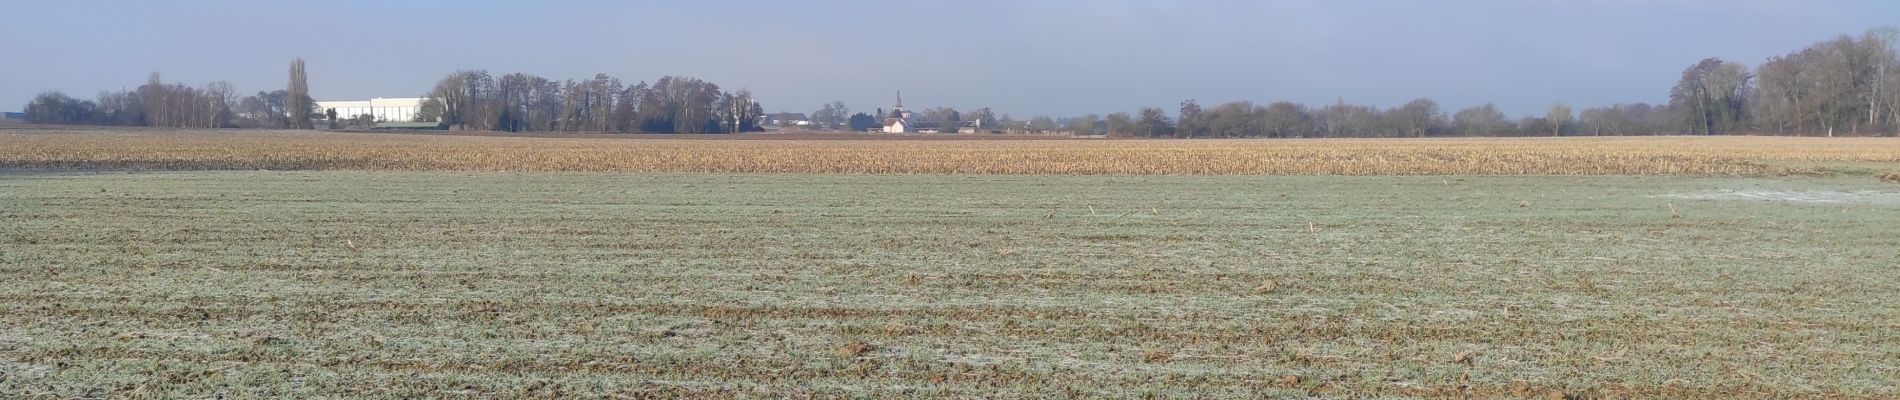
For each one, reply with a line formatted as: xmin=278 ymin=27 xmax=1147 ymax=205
xmin=1086 ymin=28 xmax=1900 ymax=138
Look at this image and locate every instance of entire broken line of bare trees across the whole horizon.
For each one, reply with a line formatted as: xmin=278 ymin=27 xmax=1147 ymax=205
xmin=27 ymin=27 xmax=1900 ymax=138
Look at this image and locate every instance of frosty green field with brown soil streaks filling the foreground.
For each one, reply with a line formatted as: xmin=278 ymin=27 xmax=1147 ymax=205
xmin=0 ymin=173 xmax=1900 ymax=398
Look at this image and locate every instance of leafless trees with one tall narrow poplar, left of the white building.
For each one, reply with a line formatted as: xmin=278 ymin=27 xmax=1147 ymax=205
xmin=27 ymin=59 xmax=317 ymax=129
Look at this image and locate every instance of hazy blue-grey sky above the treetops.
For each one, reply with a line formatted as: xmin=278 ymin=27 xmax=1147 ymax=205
xmin=0 ymin=0 xmax=1900 ymax=119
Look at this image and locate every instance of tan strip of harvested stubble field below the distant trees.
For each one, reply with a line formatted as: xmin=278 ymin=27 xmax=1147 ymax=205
xmin=0 ymin=129 xmax=1900 ymax=176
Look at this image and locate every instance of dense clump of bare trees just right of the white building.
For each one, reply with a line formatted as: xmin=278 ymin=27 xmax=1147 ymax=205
xmin=416 ymin=70 xmax=766 ymax=133
